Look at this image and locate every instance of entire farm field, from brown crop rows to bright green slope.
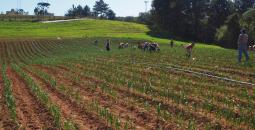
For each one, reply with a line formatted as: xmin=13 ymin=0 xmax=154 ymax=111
xmin=0 ymin=20 xmax=255 ymax=130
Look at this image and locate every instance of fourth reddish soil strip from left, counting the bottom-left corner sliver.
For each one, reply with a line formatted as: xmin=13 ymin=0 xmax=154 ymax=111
xmin=33 ymin=66 xmax=173 ymax=129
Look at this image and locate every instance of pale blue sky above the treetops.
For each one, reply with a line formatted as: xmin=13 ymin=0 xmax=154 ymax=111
xmin=0 ymin=0 xmax=151 ymax=16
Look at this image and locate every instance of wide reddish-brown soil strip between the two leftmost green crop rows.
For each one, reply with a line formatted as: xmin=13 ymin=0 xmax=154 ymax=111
xmin=7 ymin=68 xmax=55 ymax=130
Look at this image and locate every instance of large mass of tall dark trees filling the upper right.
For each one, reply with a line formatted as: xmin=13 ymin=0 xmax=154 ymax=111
xmin=145 ymin=0 xmax=255 ymax=48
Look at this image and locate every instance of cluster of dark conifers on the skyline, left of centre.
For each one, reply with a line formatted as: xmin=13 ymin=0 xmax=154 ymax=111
xmin=65 ymin=0 xmax=116 ymax=20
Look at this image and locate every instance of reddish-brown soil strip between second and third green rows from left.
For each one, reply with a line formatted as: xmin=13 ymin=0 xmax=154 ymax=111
xmin=24 ymin=67 xmax=111 ymax=130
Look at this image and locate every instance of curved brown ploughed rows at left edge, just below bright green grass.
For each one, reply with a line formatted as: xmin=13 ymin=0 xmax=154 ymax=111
xmin=0 ymin=40 xmax=64 ymax=63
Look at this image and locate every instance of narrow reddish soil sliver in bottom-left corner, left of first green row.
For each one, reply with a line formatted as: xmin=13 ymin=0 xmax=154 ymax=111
xmin=0 ymin=68 xmax=17 ymax=130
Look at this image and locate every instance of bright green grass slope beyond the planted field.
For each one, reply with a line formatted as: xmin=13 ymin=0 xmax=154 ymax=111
xmin=0 ymin=20 xmax=149 ymax=38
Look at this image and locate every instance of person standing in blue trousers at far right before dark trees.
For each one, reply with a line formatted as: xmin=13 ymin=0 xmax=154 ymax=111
xmin=238 ymin=29 xmax=249 ymax=63
